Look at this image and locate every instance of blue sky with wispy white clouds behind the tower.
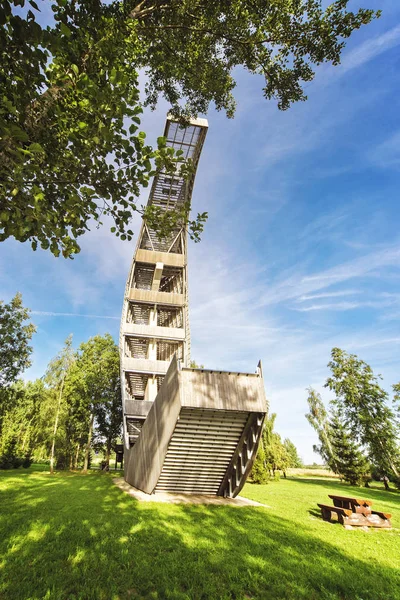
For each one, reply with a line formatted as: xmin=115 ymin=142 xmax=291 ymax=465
xmin=0 ymin=0 xmax=400 ymax=462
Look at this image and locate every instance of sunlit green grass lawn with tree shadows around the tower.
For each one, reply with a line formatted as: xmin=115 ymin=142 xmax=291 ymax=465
xmin=0 ymin=470 xmax=400 ymax=600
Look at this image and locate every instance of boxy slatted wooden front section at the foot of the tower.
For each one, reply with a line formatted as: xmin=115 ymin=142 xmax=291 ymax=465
xmin=126 ymin=359 xmax=266 ymax=497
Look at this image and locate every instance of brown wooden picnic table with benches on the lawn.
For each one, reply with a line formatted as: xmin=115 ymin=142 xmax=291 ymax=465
xmin=318 ymin=494 xmax=392 ymax=528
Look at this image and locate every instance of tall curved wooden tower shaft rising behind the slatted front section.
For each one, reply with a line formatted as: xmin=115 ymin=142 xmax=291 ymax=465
xmin=120 ymin=117 xmax=208 ymax=451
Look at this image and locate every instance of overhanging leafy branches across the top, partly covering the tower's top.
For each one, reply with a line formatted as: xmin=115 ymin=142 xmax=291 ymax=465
xmin=0 ymin=0 xmax=379 ymax=256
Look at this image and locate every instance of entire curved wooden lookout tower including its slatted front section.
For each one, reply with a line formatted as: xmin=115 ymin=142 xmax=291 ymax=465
xmin=120 ymin=117 xmax=266 ymax=496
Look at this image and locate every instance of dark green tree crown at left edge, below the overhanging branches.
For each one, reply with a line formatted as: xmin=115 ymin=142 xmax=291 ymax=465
xmin=0 ymin=293 xmax=36 ymax=390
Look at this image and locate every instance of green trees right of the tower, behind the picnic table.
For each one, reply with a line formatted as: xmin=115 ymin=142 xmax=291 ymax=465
xmin=306 ymin=348 xmax=400 ymax=484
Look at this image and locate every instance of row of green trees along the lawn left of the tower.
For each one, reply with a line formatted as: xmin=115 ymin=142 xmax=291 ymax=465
xmin=0 ymin=295 xmax=122 ymax=471
